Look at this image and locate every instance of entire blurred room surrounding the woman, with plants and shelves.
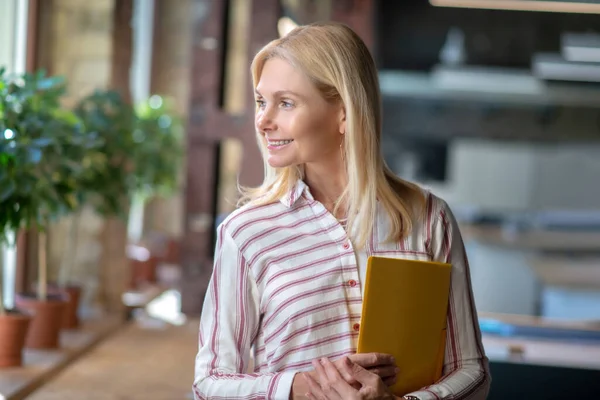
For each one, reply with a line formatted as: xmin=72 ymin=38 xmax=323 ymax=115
xmin=0 ymin=0 xmax=600 ymax=400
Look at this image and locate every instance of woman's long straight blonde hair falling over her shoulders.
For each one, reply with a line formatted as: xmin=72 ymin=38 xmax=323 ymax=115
xmin=240 ymin=22 xmax=425 ymax=248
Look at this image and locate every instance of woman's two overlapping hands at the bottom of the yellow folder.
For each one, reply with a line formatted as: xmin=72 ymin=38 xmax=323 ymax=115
xmin=304 ymin=357 xmax=395 ymax=400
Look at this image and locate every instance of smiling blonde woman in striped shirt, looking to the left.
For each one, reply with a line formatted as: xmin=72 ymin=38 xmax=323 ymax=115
xmin=194 ymin=23 xmax=490 ymax=400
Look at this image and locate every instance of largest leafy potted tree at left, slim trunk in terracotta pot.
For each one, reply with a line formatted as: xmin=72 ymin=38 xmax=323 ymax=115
xmin=0 ymin=71 xmax=99 ymax=348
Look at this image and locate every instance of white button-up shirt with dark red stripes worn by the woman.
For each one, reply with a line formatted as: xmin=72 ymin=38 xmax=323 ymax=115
xmin=194 ymin=181 xmax=490 ymax=400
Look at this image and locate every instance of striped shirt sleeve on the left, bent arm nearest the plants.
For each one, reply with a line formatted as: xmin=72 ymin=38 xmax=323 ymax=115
xmin=193 ymin=225 xmax=295 ymax=400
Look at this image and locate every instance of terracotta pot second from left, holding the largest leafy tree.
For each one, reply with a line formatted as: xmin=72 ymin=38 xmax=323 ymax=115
xmin=16 ymin=293 xmax=68 ymax=349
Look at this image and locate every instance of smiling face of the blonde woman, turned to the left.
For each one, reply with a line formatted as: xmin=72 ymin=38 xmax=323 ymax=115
xmin=255 ymin=58 xmax=345 ymax=168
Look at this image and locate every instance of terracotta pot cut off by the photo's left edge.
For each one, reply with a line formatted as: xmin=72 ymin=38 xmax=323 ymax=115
xmin=0 ymin=311 xmax=31 ymax=368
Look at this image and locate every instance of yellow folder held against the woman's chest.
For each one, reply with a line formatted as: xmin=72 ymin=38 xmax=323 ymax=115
xmin=358 ymin=257 xmax=451 ymax=396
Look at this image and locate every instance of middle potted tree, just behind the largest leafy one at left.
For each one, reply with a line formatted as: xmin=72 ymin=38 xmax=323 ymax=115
xmin=52 ymin=90 xmax=135 ymax=329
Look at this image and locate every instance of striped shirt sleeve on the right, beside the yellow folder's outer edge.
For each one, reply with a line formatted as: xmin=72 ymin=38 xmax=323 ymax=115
xmin=410 ymin=198 xmax=491 ymax=400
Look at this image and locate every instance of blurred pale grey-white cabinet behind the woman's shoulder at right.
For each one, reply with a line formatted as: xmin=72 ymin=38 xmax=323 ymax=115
xmin=424 ymin=139 xmax=600 ymax=212
